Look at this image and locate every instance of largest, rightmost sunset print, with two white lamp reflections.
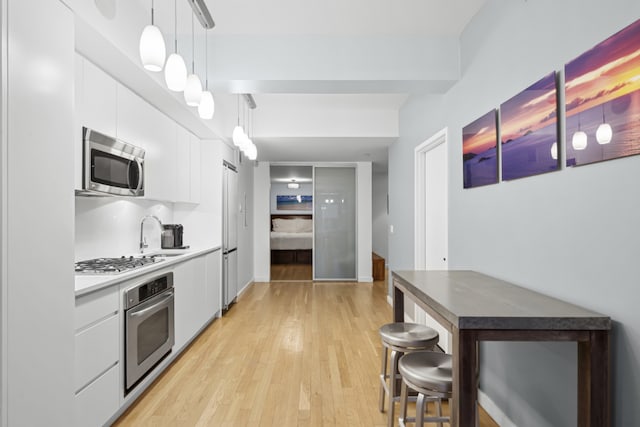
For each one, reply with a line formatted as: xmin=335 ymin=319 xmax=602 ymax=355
xmin=564 ymin=20 xmax=640 ymax=166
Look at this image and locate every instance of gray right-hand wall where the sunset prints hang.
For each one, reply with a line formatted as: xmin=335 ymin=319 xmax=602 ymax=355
xmin=389 ymin=0 xmax=640 ymax=427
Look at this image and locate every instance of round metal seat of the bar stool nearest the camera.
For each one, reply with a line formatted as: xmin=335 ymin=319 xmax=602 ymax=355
xmin=398 ymin=351 xmax=452 ymax=393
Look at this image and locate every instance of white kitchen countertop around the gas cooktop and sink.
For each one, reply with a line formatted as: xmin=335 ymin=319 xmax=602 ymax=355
xmin=75 ymin=246 xmax=221 ymax=297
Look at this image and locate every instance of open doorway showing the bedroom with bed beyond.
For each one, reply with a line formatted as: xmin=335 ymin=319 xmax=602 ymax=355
xmin=270 ymin=165 xmax=313 ymax=281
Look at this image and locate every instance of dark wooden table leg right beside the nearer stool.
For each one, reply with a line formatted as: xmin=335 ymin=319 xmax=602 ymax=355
xmin=451 ymin=327 xmax=478 ymax=427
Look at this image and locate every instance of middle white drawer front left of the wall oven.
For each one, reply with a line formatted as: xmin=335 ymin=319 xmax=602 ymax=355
xmin=75 ymin=315 xmax=120 ymax=392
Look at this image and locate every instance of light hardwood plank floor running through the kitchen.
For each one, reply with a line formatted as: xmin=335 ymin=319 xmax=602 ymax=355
xmin=115 ymin=282 xmax=497 ymax=427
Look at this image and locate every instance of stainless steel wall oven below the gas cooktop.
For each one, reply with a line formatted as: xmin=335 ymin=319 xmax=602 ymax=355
xmin=124 ymin=272 xmax=175 ymax=392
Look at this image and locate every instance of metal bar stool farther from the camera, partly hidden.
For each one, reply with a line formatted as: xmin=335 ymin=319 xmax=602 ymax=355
xmin=379 ymin=322 xmax=439 ymax=427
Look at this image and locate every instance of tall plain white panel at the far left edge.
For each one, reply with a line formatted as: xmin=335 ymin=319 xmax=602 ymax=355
xmin=0 ymin=0 xmax=74 ymax=426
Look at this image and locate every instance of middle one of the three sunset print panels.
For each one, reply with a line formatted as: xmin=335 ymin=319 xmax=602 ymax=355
xmin=500 ymin=72 xmax=560 ymax=181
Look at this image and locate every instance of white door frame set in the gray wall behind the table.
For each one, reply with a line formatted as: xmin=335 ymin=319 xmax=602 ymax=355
xmin=413 ymin=127 xmax=449 ymax=270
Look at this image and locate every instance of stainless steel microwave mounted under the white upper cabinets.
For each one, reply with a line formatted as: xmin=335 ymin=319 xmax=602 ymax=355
xmin=81 ymin=127 xmax=145 ymax=197
